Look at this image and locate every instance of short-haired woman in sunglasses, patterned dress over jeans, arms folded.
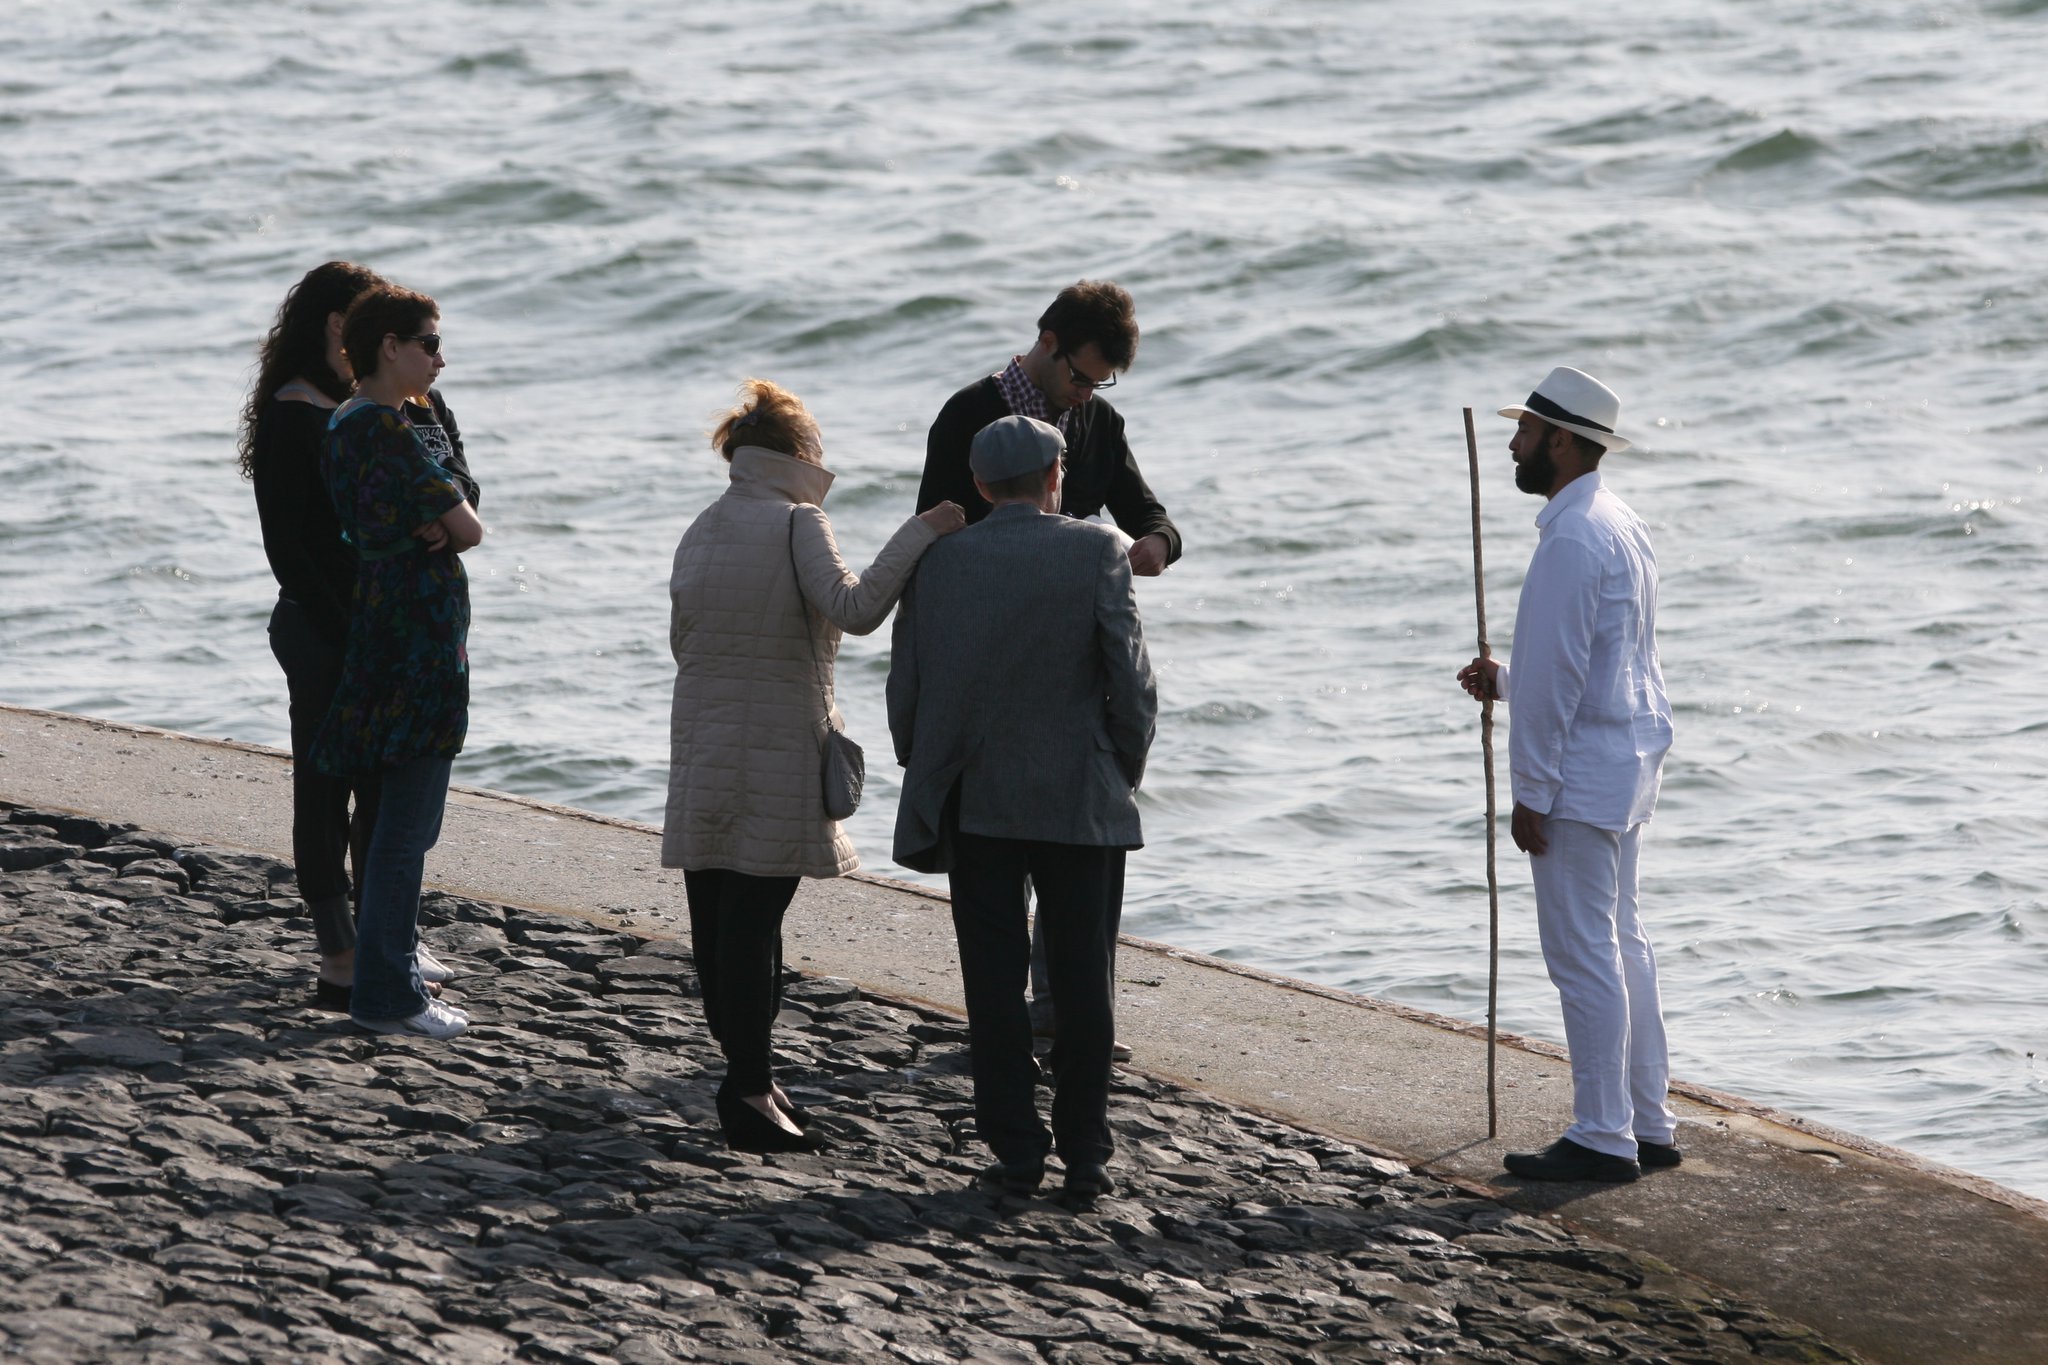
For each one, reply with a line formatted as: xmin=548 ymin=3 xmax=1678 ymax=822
xmin=311 ymin=284 xmax=483 ymax=1038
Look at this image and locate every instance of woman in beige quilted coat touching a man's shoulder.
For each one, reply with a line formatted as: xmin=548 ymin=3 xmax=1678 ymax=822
xmin=662 ymin=379 xmax=965 ymax=1152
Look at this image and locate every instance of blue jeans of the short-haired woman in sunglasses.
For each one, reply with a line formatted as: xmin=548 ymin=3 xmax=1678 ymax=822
xmin=348 ymin=759 xmax=453 ymax=1019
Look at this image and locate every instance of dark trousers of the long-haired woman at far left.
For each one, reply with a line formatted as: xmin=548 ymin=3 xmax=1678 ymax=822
xmin=270 ymin=598 xmax=377 ymax=956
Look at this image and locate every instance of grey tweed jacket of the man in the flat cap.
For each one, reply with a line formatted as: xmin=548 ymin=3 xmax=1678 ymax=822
xmin=889 ymin=503 xmax=1159 ymax=872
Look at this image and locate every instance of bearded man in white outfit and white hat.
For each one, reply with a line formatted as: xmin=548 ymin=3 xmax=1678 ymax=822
xmin=1458 ymin=366 xmax=1681 ymax=1181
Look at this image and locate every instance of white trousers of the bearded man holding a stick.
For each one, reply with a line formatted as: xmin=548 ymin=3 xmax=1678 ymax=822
xmin=1530 ymin=819 xmax=1677 ymax=1156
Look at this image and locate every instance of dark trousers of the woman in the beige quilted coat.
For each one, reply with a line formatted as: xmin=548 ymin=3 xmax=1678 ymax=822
xmin=682 ymin=868 xmax=799 ymax=1095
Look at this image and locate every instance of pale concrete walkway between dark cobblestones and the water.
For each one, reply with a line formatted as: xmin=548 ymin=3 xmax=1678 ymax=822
xmin=12 ymin=706 xmax=2048 ymax=1365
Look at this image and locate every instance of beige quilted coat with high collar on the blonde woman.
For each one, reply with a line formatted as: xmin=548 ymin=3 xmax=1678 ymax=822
xmin=662 ymin=446 xmax=938 ymax=876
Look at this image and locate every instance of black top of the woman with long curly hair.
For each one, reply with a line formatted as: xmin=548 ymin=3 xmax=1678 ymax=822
xmin=252 ymin=389 xmax=481 ymax=649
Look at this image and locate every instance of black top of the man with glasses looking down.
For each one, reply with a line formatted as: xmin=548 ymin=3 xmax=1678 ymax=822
xmin=918 ymin=375 xmax=1180 ymax=563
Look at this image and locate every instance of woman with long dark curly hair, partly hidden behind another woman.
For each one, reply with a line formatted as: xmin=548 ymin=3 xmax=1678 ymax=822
xmin=238 ymin=260 xmax=479 ymax=1011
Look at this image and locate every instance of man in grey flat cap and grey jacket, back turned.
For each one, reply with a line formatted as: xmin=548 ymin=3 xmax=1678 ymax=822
xmin=889 ymin=415 xmax=1159 ymax=1199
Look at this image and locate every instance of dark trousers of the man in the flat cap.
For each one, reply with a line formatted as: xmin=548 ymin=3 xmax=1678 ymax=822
xmin=948 ymin=833 xmax=1124 ymax=1166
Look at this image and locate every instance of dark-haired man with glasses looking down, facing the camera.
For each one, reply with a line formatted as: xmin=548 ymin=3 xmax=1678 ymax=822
xmin=918 ymin=280 xmax=1180 ymax=577
